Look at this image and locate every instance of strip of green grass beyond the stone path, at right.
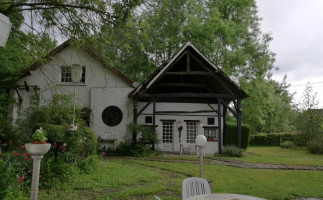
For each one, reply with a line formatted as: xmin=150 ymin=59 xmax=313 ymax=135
xmin=221 ymin=147 xmax=323 ymax=166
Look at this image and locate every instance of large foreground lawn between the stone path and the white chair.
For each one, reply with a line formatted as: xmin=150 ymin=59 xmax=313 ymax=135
xmin=17 ymin=159 xmax=323 ymax=200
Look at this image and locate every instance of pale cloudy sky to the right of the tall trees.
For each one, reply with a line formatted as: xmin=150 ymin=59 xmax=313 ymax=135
xmin=256 ymin=0 xmax=323 ymax=108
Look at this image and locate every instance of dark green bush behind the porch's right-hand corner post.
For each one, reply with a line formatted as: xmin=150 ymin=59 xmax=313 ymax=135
xmin=223 ymin=123 xmax=250 ymax=149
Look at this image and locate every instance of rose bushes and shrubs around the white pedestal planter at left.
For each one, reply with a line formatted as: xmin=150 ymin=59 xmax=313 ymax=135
xmin=0 ymin=96 xmax=97 ymax=199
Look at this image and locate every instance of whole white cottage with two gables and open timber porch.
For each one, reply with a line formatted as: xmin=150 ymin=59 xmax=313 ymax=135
xmin=12 ymin=41 xmax=248 ymax=154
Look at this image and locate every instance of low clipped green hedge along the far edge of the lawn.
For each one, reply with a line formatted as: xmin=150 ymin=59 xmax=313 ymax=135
xmin=250 ymin=133 xmax=296 ymax=146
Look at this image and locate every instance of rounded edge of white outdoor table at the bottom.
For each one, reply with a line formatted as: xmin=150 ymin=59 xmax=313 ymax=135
xmin=186 ymin=193 xmax=266 ymax=200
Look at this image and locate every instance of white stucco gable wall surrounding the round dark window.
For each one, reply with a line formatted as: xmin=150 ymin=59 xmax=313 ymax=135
xmin=11 ymin=47 xmax=133 ymax=144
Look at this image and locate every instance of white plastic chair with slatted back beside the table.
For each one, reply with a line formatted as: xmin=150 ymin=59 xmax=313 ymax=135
xmin=182 ymin=177 xmax=211 ymax=200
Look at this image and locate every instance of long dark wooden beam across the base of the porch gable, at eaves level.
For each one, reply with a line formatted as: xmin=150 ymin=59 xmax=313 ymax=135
xmin=139 ymin=93 xmax=239 ymax=100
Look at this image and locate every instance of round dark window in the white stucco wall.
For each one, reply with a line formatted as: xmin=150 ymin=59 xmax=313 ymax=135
xmin=102 ymin=106 xmax=122 ymax=126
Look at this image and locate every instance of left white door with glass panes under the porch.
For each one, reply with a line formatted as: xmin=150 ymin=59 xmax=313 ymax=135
xmin=161 ymin=121 xmax=174 ymax=152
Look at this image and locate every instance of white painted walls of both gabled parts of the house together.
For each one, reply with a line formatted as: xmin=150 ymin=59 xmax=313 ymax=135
xmin=11 ymin=46 xmax=227 ymax=154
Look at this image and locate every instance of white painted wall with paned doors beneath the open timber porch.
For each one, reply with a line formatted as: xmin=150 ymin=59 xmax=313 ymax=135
xmin=138 ymin=102 xmax=223 ymax=154
